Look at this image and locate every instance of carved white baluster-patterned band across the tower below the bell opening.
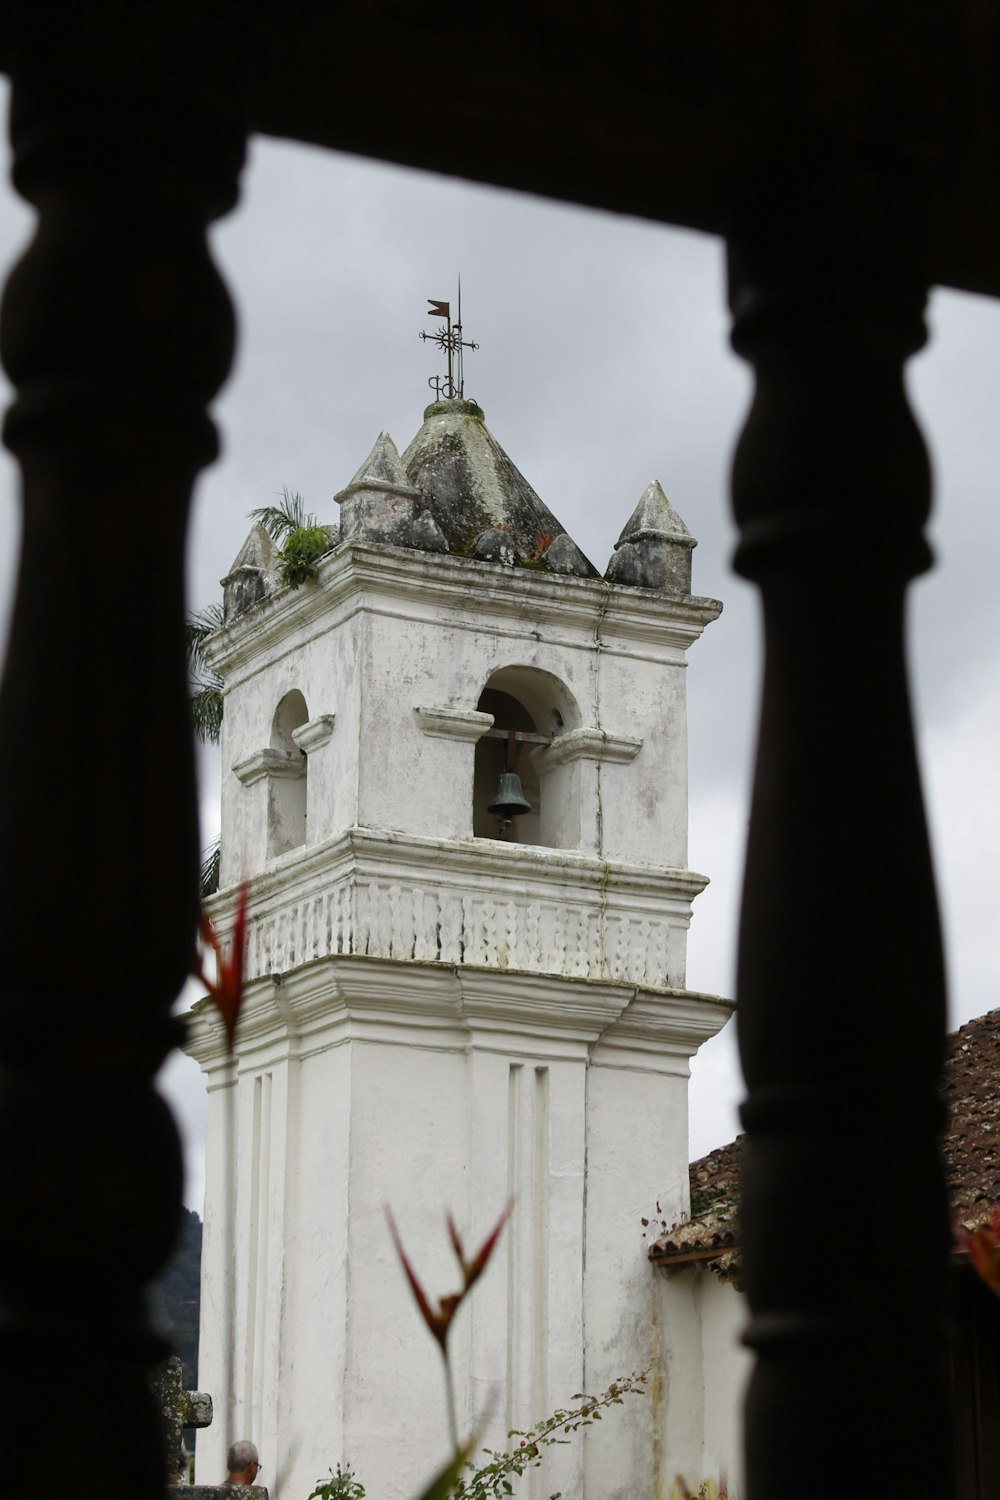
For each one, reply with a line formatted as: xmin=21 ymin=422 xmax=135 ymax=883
xmin=247 ymin=881 xmax=685 ymax=986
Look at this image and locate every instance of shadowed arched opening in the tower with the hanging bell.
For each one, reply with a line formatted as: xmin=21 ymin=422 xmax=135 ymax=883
xmin=472 ymin=666 xmax=579 ymax=848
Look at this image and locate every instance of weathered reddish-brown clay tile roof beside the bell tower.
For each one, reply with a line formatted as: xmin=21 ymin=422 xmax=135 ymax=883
xmin=649 ymin=1010 xmax=1000 ymax=1281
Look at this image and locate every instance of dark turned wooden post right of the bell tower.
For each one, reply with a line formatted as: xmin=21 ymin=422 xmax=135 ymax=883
xmin=730 ymin=164 xmax=952 ymax=1500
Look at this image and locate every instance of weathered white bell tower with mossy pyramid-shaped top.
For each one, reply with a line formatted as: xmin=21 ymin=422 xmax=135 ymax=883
xmin=189 ymin=399 xmax=730 ymax=1500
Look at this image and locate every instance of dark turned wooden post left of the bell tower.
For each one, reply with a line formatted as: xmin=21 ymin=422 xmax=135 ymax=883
xmin=0 ymin=14 xmax=243 ymax=1500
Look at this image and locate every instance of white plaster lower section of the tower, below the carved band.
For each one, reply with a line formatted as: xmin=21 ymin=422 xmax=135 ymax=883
xmin=189 ymin=956 xmax=726 ymax=1500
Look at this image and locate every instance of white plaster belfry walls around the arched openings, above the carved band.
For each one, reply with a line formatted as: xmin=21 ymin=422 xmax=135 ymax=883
xmin=208 ymin=543 xmax=718 ymax=884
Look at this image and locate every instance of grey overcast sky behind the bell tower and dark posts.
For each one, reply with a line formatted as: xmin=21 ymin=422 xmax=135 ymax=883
xmin=0 ymin=87 xmax=1000 ymax=1208
